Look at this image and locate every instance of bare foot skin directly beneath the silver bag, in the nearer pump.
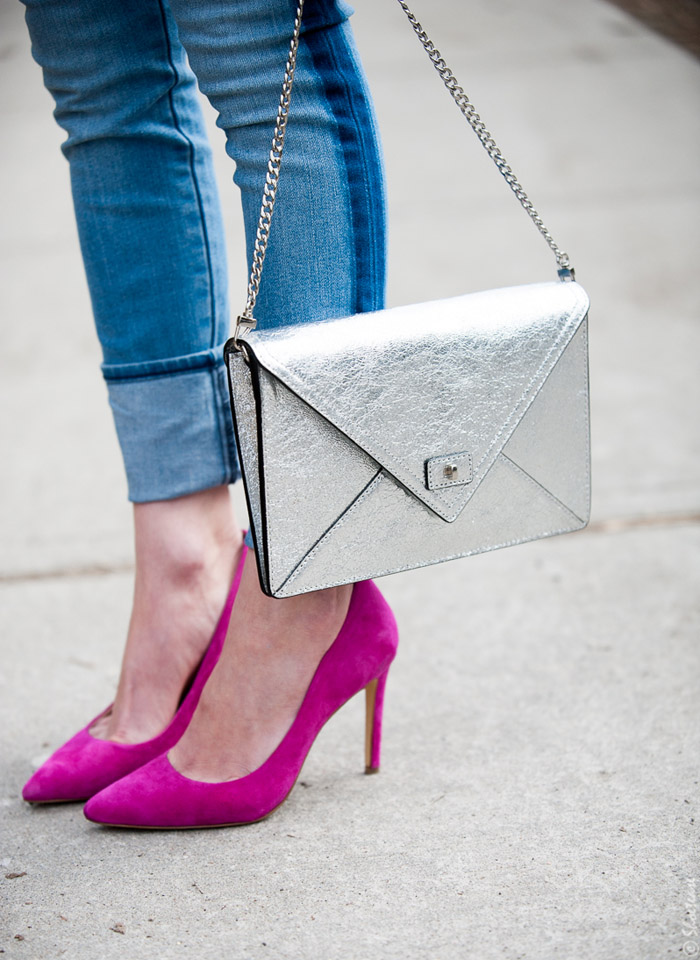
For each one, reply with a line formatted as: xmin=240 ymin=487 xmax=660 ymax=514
xmin=169 ymin=553 xmax=352 ymax=783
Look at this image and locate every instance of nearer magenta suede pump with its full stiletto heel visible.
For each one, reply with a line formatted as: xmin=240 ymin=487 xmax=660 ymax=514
xmin=85 ymin=581 xmax=398 ymax=829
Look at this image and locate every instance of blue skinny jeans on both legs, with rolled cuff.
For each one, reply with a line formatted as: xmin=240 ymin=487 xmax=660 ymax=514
xmin=23 ymin=0 xmax=385 ymax=502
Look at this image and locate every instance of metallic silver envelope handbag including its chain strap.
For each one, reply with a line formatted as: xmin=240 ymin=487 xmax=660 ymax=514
xmin=226 ymin=0 xmax=590 ymax=597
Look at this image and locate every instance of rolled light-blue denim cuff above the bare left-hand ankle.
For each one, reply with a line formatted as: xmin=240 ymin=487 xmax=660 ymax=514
xmin=102 ymin=347 xmax=241 ymax=503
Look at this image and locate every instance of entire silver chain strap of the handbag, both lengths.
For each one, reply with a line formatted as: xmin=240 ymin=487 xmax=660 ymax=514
xmin=233 ymin=0 xmax=574 ymax=347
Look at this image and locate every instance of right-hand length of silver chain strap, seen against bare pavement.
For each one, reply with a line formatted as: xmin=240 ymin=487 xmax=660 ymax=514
xmin=397 ymin=0 xmax=573 ymax=273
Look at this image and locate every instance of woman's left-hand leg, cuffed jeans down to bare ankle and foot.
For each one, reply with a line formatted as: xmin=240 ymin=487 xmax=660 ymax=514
xmin=26 ymin=0 xmax=240 ymax=742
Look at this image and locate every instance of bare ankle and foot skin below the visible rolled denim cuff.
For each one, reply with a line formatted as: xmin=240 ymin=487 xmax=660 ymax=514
xmin=91 ymin=487 xmax=242 ymax=743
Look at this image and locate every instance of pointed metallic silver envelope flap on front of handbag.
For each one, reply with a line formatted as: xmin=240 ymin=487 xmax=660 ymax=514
xmin=246 ymin=281 xmax=588 ymax=522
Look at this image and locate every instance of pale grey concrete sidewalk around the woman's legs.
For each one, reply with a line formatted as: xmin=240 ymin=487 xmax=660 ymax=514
xmin=0 ymin=0 xmax=700 ymax=960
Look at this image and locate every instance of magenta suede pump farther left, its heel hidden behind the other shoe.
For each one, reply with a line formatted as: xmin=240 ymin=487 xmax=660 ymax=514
xmin=22 ymin=546 xmax=248 ymax=803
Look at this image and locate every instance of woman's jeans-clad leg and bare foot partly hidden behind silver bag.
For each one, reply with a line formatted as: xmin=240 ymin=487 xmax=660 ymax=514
xmin=164 ymin=0 xmax=392 ymax=781
